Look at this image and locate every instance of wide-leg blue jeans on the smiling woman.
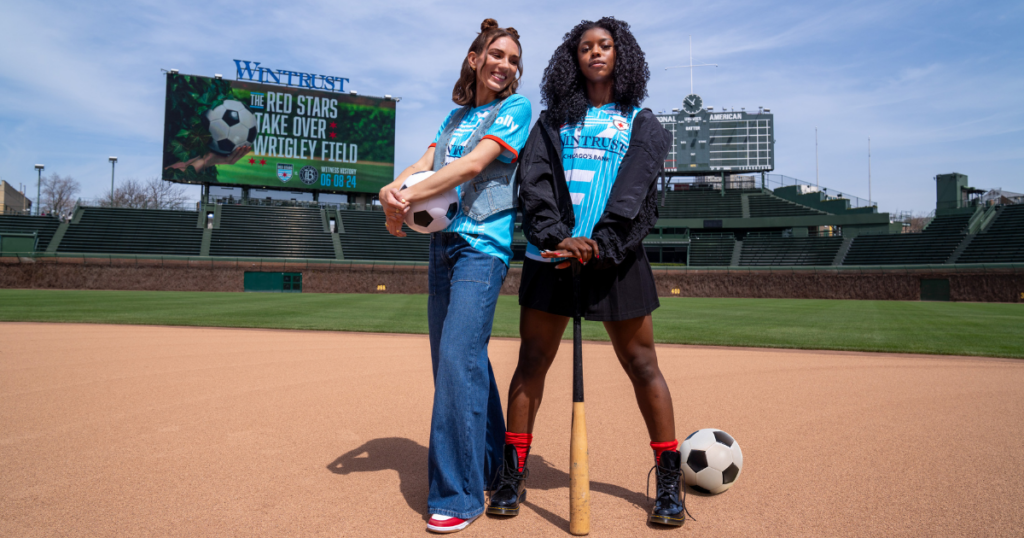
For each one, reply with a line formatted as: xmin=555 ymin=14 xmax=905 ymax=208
xmin=427 ymin=232 xmax=508 ymax=520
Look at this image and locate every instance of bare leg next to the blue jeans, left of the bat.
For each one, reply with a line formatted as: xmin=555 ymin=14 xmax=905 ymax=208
xmin=506 ymin=306 xmax=569 ymax=433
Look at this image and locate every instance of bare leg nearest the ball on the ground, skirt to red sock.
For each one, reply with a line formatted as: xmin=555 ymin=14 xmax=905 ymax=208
xmin=602 ymin=316 xmax=676 ymax=443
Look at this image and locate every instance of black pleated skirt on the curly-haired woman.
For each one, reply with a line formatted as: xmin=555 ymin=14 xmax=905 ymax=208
xmin=519 ymin=241 xmax=662 ymax=322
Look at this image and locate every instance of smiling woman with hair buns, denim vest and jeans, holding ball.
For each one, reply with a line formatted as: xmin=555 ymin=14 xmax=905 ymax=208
xmin=380 ymin=18 xmax=531 ymax=533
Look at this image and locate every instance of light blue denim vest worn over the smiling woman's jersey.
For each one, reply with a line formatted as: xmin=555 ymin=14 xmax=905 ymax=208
xmin=434 ymin=99 xmax=518 ymax=222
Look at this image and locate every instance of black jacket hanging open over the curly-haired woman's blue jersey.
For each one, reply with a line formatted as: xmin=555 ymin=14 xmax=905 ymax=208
xmin=516 ymin=109 xmax=672 ymax=267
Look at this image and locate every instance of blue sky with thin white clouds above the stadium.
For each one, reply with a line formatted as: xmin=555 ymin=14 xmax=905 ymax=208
xmin=0 ymin=0 xmax=1024 ymax=212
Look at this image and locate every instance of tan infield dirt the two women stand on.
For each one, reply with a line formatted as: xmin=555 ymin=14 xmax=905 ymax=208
xmin=0 ymin=323 xmax=1024 ymax=538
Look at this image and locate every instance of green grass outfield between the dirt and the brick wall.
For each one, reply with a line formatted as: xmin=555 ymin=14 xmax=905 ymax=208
xmin=0 ymin=290 xmax=1024 ymax=359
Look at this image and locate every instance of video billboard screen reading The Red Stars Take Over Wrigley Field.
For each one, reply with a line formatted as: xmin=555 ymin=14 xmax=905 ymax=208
xmin=163 ymin=74 xmax=395 ymax=193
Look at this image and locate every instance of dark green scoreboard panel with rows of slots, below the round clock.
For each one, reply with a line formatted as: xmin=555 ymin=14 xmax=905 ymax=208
xmin=655 ymin=109 xmax=775 ymax=175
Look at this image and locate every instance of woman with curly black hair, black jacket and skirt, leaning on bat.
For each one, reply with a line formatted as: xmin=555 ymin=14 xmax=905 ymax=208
xmin=487 ymin=17 xmax=685 ymax=526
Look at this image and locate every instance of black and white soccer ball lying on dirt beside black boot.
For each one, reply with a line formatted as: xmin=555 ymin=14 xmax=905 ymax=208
xmin=679 ymin=427 xmax=743 ymax=493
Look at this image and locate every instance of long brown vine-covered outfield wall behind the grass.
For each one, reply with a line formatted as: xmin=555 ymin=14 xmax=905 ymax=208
xmin=0 ymin=258 xmax=1024 ymax=302
